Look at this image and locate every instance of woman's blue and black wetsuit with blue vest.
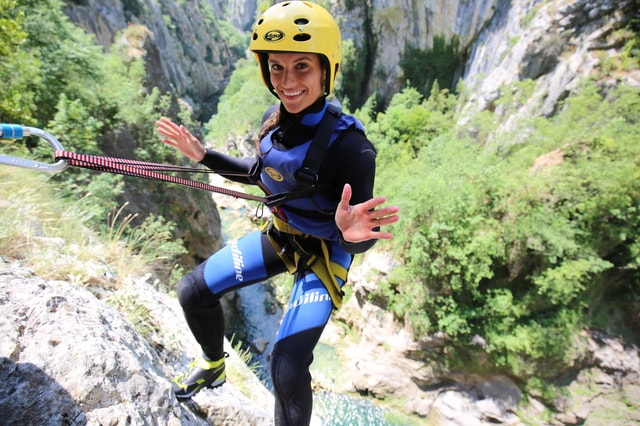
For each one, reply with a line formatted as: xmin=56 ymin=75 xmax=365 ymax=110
xmin=178 ymin=98 xmax=375 ymax=425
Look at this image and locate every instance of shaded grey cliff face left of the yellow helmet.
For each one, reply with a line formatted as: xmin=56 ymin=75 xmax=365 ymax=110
xmin=65 ymin=0 xmax=256 ymax=118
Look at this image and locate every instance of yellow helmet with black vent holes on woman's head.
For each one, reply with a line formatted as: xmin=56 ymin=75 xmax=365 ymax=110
xmin=249 ymin=1 xmax=342 ymax=97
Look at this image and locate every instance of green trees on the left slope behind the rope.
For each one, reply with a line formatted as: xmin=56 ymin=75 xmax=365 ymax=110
xmin=0 ymin=0 xmax=198 ymax=280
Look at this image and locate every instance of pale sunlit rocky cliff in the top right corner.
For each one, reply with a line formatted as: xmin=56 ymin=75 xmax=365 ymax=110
xmin=463 ymin=0 xmax=640 ymax=128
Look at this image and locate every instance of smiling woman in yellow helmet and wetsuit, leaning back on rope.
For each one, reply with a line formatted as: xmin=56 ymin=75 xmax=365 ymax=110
xmin=157 ymin=1 xmax=398 ymax=425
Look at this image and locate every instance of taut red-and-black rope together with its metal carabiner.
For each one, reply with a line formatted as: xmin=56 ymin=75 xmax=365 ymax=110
xmin=0 ymin=124 xmax=286 ymax=207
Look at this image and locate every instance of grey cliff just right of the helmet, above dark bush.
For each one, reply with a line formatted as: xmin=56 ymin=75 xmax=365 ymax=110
xmin=332 ymin=0 xmax=498 ymax=106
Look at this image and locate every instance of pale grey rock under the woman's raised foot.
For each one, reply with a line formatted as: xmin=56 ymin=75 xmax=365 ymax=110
xmin=0 ymin=258 xmax=273 ymax=426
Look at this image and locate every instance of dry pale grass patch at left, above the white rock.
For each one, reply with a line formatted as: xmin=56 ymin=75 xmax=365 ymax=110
xmin=0 ymin=166 xmax=184 ymax=289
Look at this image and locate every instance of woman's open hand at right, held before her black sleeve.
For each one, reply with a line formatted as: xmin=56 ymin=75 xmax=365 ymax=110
xmin=336 ymin=184 xmax=400 ymax=243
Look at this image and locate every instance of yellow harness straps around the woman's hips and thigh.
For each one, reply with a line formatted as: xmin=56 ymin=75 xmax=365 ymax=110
xmin=262 ymin=216 xmax=348 ymax=309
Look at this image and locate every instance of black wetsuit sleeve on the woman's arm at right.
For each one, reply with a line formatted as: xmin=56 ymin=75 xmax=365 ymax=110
xmin=331 ymin=129 xmax=377 ymax=254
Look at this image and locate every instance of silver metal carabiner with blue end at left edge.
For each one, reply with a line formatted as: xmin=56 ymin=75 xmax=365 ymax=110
xmin=0 ymin=123 xmax=69 ymax=173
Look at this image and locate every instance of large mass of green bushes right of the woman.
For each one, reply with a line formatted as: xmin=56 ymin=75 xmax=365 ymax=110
xmin=370 ymin=77 xmax=640 ymax=386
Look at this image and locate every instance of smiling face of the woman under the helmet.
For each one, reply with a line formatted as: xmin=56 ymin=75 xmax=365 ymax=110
xmin=268 ymin=53 xmax=325 ymax=114
